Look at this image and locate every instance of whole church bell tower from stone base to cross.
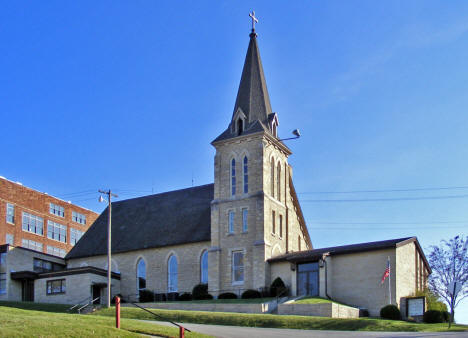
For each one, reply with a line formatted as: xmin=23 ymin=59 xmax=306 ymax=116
xmin=208 ymin=12 xmax=311 ymax=295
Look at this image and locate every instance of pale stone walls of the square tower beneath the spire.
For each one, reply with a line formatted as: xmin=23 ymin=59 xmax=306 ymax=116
xmin=209 ymin=133 xmax=306 ymax=295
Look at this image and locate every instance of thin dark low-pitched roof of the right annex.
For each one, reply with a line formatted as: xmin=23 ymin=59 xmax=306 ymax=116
xmin=268 ymin=237 xmax=431 ymax=273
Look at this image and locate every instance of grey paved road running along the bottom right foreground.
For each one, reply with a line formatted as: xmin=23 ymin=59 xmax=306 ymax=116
xmin=147 ymin=320 xmax=468 ymax=338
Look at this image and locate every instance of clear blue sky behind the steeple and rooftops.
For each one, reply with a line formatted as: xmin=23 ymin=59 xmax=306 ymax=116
xmin=0 ymin=1 xmax=468 ymax=323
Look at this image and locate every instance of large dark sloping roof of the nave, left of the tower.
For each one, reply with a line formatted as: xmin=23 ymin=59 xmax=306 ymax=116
xmin=65 ymin=184 xmax=214 ymax=259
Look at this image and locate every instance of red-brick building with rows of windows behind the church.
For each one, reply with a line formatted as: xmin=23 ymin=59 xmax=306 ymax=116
xmin=0 ymin=177 xmax=98 ymax=257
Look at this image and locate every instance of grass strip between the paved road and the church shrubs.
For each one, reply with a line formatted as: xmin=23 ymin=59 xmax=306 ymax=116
xmin=94 ymin=307 xmax=468 ymax=332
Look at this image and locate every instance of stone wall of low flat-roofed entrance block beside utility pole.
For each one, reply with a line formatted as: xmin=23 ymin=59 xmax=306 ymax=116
xmin=34 ymin=273 xmax=120 ymax=305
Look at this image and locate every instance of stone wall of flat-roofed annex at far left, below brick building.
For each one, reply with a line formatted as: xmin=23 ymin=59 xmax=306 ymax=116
xmin=0 ymin=245 xmax=65 ymax=301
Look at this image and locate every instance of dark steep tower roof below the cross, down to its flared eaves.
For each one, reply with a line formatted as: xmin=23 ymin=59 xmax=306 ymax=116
xmin=213 ymin=32 xmax=272 ymax=142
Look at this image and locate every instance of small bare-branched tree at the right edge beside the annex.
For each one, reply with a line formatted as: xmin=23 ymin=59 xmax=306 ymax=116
xmin=429 ymin=236 xmax=468 ymax=327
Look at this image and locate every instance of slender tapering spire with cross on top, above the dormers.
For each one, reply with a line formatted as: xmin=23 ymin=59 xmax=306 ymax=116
xmin=234 ymin=12 xmax=272 ymax=125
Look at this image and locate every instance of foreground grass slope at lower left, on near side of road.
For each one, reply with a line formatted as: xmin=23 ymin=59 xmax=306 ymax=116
xmin=0 ymin=303 xmax=209 ymax=338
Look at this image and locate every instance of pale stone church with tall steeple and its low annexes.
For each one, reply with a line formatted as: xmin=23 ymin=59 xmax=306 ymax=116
xmin=0 ymin=21 xmax=431 ymax=315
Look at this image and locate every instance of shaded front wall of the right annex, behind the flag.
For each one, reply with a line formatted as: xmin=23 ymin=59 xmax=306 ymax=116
xmin=328 ymin=249 xmax=398 ymax=316
